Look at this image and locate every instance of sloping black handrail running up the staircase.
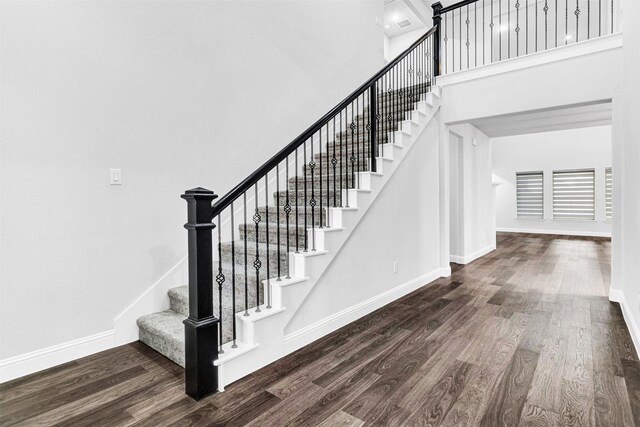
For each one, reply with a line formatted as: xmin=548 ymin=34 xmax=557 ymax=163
xmin=211 ymin=27 xmax=436 ymax=219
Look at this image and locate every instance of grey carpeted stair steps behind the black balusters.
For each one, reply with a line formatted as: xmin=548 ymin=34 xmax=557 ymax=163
xmin=137 ymin=85 xmax=439 ymax=367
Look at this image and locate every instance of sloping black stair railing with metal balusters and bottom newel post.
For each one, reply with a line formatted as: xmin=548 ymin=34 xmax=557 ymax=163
xmin=182 ymin=28 xmax=436 ymax=399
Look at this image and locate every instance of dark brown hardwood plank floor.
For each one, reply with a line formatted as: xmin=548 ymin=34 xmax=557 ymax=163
xmin=0 ymin=234 xmax=640 ymax=427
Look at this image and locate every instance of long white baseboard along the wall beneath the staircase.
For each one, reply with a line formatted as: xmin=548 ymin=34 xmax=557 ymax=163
xmin=284 ymin=268 xmax=442 ymax=349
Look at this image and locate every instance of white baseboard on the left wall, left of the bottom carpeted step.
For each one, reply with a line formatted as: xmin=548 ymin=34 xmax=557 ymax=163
xmin=0 ymin=331 xmax=115 ymax=383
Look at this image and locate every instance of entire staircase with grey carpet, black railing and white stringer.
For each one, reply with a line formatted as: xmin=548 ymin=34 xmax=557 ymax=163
xmin=137 ymin=27 xmax=440 ymax=399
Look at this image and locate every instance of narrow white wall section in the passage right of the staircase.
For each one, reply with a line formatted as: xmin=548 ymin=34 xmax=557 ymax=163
xmin=448 ymin=124 xmax=496 ymax=264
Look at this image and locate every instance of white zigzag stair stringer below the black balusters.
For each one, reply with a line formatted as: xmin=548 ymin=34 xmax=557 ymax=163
xmin=215 ymin=87 xmax=440 ymax=391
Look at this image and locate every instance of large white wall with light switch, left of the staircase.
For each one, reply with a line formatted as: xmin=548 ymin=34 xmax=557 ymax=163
xmin=0 ymin=1 xmax=384 ymax=359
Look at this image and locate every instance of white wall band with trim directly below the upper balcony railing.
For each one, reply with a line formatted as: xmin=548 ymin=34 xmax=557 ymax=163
xmin=437 ymin=36 xmax=622 ymax=123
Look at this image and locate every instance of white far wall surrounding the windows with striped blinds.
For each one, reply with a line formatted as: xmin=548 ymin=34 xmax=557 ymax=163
xmin=493 ymin=126 xmax=611 ymax=236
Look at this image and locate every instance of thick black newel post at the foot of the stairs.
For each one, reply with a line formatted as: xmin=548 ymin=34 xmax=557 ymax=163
xmin=181 ymin=188 xmax=220 ymax=400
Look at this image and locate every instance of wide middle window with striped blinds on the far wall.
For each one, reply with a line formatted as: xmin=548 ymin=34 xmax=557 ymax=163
xmin=553 ymin=169 xmax=595 ymax=220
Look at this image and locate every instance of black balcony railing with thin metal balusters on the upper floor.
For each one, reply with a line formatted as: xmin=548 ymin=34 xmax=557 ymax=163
xmin=431 ymin=0 xmax=620 ymax=74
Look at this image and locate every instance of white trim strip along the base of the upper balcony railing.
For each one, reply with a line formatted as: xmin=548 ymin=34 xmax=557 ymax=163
xmin=438 ymin=33 xmax=622 ymax=87
